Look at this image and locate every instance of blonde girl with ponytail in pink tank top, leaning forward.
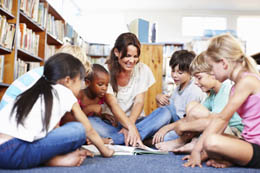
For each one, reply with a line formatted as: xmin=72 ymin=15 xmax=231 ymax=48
xmin=184 ymin=34 xmax=260 ymax=168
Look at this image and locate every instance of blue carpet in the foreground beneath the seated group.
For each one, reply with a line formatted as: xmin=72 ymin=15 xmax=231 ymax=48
xmin=0 ymin=153 xmax=260 ymax=173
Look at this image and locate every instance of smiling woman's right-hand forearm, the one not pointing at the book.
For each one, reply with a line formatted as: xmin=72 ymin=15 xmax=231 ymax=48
xmin=129 ymin=92 xmax=145 ymax=124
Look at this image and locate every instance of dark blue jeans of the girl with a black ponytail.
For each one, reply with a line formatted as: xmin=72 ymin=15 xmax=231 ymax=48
xmin=0 ymin=122 xmax=86 ymax=169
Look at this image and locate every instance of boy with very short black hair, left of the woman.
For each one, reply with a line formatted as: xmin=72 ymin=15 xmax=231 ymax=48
xmin=61 ymin=64 xmax=116 ymax=130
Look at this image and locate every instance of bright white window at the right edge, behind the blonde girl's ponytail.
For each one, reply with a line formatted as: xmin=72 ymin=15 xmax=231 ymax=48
xmin=237 ymin=17 xmax=260 ymax=55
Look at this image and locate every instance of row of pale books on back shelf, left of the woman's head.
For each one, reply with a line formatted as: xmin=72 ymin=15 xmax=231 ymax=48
xmin=88 ymin=43 xmax=110 ymax=56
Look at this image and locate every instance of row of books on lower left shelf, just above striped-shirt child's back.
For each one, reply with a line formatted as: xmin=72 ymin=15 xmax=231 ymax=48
xmin=16 ymin=58 xmax=40 ymax=78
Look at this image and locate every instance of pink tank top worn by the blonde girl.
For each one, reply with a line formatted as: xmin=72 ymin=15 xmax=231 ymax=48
xmin=231 ymin=73 xmax=260 ymax=145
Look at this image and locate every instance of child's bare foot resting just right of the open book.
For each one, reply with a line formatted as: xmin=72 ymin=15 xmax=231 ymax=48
xmin=155 ymin=138 xmax=184 ymax=151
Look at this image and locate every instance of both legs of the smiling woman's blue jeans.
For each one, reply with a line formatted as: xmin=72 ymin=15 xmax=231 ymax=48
xmin=88 ymin=106 xmax=175 ymax=144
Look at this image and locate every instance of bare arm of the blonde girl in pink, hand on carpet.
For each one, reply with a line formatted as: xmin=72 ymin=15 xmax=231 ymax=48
xmin=184 ymin=78 xmax=256 ymax=167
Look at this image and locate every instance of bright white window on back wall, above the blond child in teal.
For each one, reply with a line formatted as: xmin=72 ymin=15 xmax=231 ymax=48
xmin=182 ymin=17 xmax=227 ymax=36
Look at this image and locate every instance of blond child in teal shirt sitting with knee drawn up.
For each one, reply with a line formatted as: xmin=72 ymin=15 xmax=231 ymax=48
xmin=158 ymin=52 xmax=243 ymax=152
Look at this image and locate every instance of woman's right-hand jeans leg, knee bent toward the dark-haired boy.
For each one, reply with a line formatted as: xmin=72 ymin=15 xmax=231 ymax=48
xmin=136 ymin=106 xmax=172 ymax=140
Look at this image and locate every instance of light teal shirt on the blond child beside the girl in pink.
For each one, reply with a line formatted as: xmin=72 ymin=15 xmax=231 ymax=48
xmin=203 ymin=80 xmax=243 ymax=131
